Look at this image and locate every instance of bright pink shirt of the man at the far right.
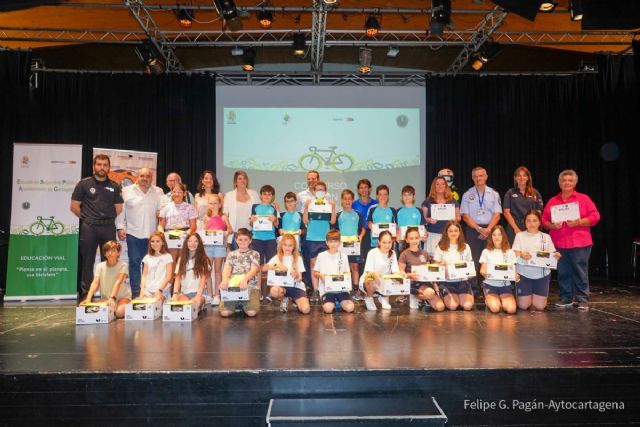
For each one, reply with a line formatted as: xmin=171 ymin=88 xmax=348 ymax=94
xmin=542 ymin=190 xmax=600 ymax=249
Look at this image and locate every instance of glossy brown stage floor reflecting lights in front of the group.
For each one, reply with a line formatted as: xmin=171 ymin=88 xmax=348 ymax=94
xmin=0 ymin=282 xmax=640 ymax=374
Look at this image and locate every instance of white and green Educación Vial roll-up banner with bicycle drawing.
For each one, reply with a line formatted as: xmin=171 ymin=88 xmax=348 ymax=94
xmin=7 ymin=143 xmax=82 ymax=299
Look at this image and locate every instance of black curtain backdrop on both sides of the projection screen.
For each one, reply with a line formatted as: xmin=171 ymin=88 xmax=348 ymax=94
xmin=0 ymin=50 xmax=640 ymax=277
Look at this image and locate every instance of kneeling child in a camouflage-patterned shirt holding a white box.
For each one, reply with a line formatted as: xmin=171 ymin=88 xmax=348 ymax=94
xmin=219 ymin=228 xmax=260 ymax=317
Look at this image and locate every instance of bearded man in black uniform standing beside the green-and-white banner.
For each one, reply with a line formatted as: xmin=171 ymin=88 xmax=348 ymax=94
xmin=70 ymin=154 xmax=123 ymax=301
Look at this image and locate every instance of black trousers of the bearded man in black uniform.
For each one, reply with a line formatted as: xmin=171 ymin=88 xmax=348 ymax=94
xmin=78 ymin=222 xmax=116 ymax=301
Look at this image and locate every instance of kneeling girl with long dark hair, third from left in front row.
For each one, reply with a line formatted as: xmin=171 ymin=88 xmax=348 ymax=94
xmin=171 ymin=232 xmax=211 ymax=313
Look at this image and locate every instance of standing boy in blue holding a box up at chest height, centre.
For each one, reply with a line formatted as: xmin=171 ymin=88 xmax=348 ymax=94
xmin=302 ymin=181 xmax=336 ymax=303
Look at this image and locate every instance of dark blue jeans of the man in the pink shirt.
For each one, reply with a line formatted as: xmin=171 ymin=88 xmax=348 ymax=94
xmin=558 ymin=246 xmax=591 ymax=303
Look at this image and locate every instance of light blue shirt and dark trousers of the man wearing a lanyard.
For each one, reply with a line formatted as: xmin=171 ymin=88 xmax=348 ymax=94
xmin=460 ymin=186 xmax=502 ymax=271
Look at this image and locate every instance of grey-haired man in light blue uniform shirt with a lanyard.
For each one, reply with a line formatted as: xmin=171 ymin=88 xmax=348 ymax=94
xmin=460 ymin=166 xmax=502 ymax=272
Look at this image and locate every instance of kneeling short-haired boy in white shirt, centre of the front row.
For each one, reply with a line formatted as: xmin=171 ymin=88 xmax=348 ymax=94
xmin=313 ymin=230 xmax=355 ymax=314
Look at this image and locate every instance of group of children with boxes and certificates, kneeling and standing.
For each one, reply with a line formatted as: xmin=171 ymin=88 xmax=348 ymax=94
xmin=80 ymin=181 xmax=560 ymax=317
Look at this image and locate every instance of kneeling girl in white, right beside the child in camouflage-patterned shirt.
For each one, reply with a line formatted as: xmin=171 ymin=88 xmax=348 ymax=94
xmin=262 ymin=234 xmax=310 ymax=314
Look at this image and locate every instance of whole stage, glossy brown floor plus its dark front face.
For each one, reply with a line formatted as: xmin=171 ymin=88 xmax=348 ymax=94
xmin=0 ymin=281 xmax=640 ymax=426
